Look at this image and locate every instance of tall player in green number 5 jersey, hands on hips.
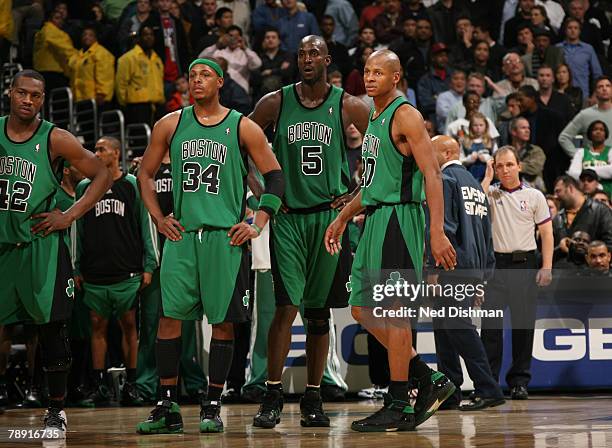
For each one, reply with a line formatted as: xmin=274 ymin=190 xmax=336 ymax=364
xmin=251 ymin=36 xmax=368 ymax=428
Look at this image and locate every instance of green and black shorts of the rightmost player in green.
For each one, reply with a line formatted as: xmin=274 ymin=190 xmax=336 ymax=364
xmin=349 ymin=203 xmax=425 ymax=307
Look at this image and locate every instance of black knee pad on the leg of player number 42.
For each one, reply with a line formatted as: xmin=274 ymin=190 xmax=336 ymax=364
xmin=38 ymin=322 xmax=72 ymax=372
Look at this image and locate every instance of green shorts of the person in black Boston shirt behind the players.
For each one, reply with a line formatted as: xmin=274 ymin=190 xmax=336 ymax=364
xmin=83 ymin=275 xmax=142 ymax=319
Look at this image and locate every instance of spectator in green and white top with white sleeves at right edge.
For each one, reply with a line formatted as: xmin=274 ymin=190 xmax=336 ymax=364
xmin=567 ymin=120 xmax=612 ymax=194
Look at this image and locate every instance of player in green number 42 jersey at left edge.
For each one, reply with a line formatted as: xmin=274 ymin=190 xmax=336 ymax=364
xmin=0 ymin=70 xmax=112 ymax=438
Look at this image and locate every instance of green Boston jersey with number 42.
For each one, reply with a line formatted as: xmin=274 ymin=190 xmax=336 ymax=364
xmin=0 ymin=116 xmax=60 ymax=243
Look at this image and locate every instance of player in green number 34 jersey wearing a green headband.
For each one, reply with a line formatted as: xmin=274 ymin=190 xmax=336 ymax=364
xmin=137 ymin=59 xmax=284 ymax=434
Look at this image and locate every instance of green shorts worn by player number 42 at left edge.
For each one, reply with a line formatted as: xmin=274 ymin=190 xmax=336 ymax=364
xmin=0 ymin=232 xmax=74 ymax=325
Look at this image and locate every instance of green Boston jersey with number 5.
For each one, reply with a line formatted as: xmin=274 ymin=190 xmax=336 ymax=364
xmin=272 ymin=84 xmax=350 ymax=208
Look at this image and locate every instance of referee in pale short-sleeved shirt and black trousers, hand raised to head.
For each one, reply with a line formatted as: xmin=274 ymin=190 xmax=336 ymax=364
xmin=481 ymin=146 xmax=554 ymax=400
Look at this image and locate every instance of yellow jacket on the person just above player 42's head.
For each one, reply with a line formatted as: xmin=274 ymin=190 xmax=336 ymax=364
xmin=34 ymin=22 xmax=77 ymax=76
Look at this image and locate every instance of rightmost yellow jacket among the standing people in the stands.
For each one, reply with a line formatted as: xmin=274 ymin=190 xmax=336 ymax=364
xmin=115 ymin=45 xmax=165 ymax=106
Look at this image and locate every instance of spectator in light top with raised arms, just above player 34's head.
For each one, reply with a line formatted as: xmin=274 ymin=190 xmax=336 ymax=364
xmin=200 ymin=25 xmax=261 ymax=94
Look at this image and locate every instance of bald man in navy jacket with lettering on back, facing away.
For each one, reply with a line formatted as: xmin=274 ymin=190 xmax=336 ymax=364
xmin=432 ymin=135 xmax=505 ymax=411
